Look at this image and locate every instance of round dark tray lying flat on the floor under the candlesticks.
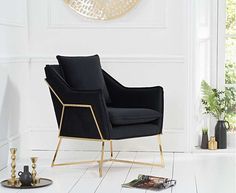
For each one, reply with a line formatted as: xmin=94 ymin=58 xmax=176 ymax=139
xmin=1 ymin=178 xmax=52 ymax=189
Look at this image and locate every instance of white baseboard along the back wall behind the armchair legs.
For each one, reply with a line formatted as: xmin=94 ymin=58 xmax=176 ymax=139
xmin=29 ymin=130 xmax=186 ymax=152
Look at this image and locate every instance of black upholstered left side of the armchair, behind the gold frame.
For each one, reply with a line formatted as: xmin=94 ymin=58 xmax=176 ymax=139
xmin=45 ymin=65 xmax=111 ymax=139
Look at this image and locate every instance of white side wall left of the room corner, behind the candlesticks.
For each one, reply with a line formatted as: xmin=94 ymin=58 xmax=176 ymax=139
xmin=0 ymin=0 xmax=28 ymax=169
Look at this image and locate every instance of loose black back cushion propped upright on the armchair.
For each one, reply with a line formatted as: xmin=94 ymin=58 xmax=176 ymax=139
xmin=57 ymin=55 xmax=110 ymax=103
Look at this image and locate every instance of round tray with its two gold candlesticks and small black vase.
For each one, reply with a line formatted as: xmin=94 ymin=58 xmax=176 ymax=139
xmin=1 ymin=148 xmax=52 ymax=189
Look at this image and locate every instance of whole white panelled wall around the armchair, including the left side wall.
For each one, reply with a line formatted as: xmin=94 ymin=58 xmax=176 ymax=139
xmin=0 ymin=0 xmax=192 ymax=158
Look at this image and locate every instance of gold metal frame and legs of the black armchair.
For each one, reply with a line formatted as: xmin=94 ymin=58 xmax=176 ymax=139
xmin=46 ymin=81 xmax=165 ymax=177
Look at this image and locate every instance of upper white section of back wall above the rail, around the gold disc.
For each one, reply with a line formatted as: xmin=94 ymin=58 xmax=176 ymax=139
xmin=28 ymin=0 xmax=186 ymax=60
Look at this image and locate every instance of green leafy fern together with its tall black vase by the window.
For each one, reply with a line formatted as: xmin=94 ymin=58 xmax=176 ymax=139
xmin=201 ymin=80 xmax=236 ymax=149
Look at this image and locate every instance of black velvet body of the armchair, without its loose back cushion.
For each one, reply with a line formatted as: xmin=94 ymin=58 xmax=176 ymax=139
xmin=45 ymin=60 xmax=164 ymax=140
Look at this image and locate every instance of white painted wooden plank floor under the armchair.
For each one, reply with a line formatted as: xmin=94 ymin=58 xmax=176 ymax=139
xmin=0 ymin=151 xmax=236 ymax=193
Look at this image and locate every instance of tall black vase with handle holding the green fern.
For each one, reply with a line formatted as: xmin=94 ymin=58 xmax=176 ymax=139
xmin=215 ymin=121 xmax=229 ymax=149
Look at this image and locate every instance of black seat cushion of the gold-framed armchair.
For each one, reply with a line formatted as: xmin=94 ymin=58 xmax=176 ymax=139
xmin=108 ymin=107 xmax=161 ymax=125
